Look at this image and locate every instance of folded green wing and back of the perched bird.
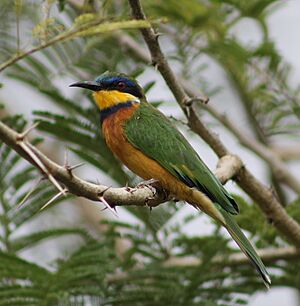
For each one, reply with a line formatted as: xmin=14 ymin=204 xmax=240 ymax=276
xmin=124 ymin=102 xmax=239 ymax=214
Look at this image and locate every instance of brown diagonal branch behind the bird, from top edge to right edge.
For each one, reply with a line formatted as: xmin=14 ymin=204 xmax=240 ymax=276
xmin=128 ymin=0 xmax=300 ymax=246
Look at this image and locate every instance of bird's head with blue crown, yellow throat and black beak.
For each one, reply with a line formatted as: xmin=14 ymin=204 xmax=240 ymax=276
xmin=70 ymin=72 xmax=144 ymax=110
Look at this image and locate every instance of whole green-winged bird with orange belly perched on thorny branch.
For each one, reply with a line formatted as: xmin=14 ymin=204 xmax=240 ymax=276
xmin=70 ymin=72 xmax=271 ymax=288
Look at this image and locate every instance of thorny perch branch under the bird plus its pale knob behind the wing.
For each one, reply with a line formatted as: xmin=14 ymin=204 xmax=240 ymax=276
xmin=0 ymin=121 xmax=241 ymax=207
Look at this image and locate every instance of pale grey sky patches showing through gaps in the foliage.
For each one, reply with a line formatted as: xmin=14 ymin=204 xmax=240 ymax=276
xmin=0 ymin=0 xmax=300 ymax=306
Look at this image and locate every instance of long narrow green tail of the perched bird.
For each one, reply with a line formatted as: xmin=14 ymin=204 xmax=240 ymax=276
xmin=220 ymin=208 xmax=271 ymax=289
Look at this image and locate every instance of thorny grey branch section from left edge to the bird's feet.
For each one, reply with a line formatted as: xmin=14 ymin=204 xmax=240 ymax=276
xmin=0 ymin=121 xmax=168 ymax=207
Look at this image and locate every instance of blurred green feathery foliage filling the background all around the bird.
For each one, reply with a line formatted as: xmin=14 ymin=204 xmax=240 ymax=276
xmin=0 ymin=0 xmax=300 ymax=306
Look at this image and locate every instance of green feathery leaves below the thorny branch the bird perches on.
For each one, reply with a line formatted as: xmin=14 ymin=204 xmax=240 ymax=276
xmin=0 ymin=116 xmax=278 ymax=305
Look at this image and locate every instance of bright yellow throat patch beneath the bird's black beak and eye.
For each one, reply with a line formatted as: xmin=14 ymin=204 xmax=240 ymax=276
xmin=93 ymin=90 xmax=138 ymax=110
